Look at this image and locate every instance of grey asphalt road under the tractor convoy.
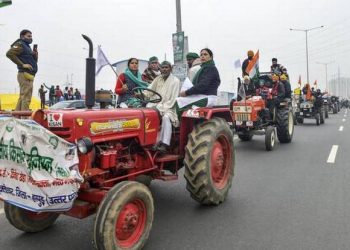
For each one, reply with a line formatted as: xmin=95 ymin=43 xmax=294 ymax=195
xmin=0 ymin=110 xmax=350 ymax=250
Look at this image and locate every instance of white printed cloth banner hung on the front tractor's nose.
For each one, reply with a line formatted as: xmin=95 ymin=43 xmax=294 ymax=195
xmin=0 ymin=116 xmax=83 ymax=212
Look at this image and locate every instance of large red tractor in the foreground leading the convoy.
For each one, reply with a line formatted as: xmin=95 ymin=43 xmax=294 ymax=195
xmin=4 ymin=37 xmax=235 ymax=249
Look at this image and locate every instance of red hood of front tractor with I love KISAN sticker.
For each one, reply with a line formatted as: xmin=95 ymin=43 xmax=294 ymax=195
xmin=34 ymin=108 xmax=160 ymax=144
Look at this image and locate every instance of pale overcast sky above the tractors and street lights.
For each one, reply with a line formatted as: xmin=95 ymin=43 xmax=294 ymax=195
xmin=0 ymin=0 xmax=350 ymax=95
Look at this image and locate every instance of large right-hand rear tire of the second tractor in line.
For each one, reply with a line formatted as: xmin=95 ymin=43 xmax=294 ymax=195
xmin=276 ymin=109 xmax=294 ymax=143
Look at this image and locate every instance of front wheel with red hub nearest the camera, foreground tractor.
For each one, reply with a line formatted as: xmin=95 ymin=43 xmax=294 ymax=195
xmin=93 ymin=181 xmax=154 ymax=250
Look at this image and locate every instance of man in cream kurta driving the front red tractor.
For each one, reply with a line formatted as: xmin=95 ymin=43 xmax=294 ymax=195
xmin=145 ymin=61 xmax=180 ymax=153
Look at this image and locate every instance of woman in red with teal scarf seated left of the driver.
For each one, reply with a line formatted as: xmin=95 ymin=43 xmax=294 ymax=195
xmin=115 ymin=58 xmax=148 ymax=108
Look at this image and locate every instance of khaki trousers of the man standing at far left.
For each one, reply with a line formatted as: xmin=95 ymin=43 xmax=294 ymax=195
xmin=16 ymin=72 xmax=34 ymax=111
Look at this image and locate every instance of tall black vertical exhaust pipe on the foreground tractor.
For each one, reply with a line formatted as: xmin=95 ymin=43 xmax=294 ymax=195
xmin=82 ymin=35 xmax=96 ymax=109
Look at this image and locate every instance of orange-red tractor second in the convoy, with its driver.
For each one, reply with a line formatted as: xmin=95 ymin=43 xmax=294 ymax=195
xmin=230 ymin=74 xmax=294 ymax=151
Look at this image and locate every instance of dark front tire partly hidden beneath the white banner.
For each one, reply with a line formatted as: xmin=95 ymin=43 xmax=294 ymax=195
xmin=4 ymin=202 xmax=60 ymax=233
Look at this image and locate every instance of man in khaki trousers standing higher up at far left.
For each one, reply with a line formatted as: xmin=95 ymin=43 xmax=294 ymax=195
xmin=6 ymin=30 xmax=38 ymax=111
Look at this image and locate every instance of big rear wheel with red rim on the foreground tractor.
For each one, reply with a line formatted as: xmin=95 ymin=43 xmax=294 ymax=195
xmin=184 ymin=117 xmax=235 ymax=205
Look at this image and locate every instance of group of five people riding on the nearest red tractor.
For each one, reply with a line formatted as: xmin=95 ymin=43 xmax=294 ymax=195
xmin=115 ymin=48 xmax=220 ymax=152
